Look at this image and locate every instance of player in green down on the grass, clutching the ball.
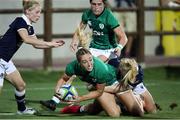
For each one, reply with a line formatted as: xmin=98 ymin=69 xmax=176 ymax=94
xmin=40 ymin=48 xmax=143 ymax=117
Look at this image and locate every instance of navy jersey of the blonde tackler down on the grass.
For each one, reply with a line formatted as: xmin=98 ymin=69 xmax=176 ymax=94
xmin=108 ymin=58 xmax=144 ymax=87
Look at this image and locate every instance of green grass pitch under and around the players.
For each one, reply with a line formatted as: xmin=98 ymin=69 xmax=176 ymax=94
xmin=0 ymin=68 xmax=180 ymax=119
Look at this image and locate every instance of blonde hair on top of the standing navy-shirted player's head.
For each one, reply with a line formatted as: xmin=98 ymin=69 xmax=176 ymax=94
xmin=22 ymin=0 xmax=40 ymax=12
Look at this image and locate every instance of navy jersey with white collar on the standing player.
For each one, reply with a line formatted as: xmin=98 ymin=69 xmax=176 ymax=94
xmin=0 ymin=15 xmax=34 ymax=62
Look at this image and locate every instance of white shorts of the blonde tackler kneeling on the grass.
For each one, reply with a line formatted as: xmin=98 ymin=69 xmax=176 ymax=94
xmin=133 ymin=83 xmax=147 ymax=95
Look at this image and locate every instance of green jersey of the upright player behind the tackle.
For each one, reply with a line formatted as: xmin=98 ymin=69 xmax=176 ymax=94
xmin=82 ymin=8 xmax=119 ymax=50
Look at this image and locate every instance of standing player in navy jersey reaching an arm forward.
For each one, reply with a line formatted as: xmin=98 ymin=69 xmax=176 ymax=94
xmin=0 ymin=0 xmax=64 ymax=115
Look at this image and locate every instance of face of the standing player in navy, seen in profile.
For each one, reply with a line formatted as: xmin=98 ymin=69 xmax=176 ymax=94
xmin=27 ymin=5 xmax=41 ymax=23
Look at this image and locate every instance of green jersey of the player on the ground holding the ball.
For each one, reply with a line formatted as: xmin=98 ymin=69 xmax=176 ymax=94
xmin=65 ymin=57 xmax=116 ymax=85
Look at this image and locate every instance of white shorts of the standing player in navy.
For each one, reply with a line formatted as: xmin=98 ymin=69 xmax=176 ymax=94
xmin=0 ymin=58 xmax=16 ymax=87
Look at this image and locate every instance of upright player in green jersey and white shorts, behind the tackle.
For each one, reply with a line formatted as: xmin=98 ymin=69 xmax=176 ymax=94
xmin=70 ymin=0 xmax=128 ymax=62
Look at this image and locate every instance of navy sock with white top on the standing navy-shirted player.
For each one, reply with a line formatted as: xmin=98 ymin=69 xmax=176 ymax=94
xmin=15 ymin=89 xmax=26 ymax=111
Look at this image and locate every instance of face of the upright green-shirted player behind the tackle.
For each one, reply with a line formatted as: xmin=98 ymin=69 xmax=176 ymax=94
xmin=91 ymin=0 xmax=104 ymax=16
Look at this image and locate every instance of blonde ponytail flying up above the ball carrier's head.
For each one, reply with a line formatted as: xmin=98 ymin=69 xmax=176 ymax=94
xmin=77 ymin=26 xmax=92 ymax=48
